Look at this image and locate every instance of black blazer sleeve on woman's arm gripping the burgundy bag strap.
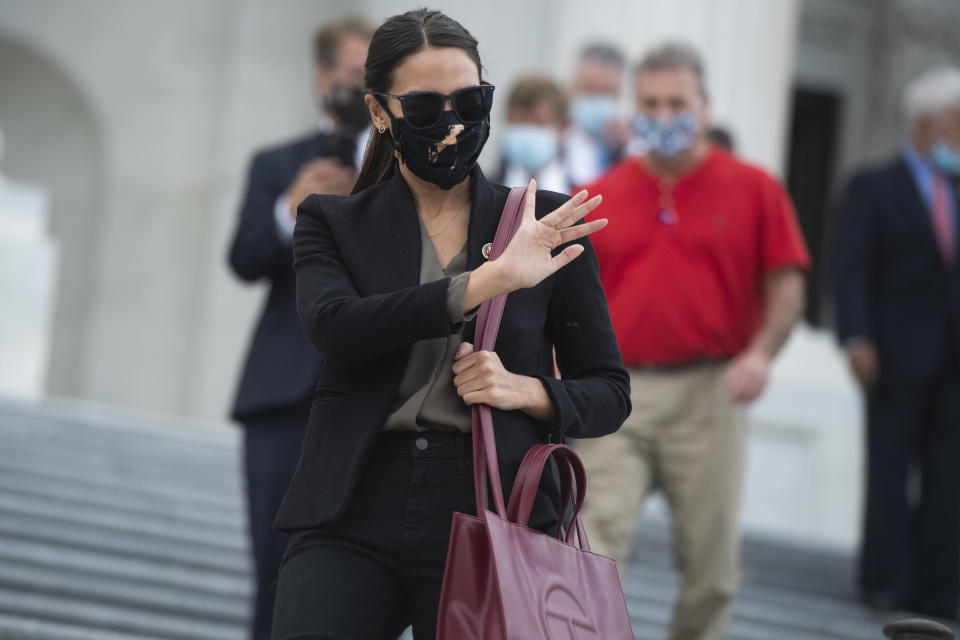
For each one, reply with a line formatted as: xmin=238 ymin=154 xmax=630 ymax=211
xmin=537 ymin=224 xmax=631 ymax=438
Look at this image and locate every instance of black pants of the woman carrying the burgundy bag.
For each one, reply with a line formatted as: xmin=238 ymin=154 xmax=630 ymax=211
xmin=273 ymin=432 xmax=476 ymax=640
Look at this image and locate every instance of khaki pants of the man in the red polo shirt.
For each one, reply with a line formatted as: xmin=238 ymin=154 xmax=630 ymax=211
xmin=577 ymin=364 xmax=746 ymax=640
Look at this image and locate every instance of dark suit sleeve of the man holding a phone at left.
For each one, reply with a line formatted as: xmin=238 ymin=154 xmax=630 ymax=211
xmin=230 ymin=153 xmax=290 ymax=281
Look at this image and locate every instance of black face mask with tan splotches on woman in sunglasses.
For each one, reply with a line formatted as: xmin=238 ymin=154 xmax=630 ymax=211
xmin=386 ymin=109 xmax=490 ymax=189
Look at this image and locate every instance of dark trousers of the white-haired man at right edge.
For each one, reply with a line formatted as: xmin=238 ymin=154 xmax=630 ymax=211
xmin=860 ymin=357 xmax=960 ymax=618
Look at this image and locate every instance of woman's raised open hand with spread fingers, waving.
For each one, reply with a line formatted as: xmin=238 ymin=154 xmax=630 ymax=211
xmin=494 ymin=180 xmax=607 ymax=290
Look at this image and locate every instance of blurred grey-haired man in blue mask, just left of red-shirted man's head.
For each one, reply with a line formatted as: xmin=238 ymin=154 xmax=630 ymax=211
xmin=563 ymin=44 xmax=630 ymax=185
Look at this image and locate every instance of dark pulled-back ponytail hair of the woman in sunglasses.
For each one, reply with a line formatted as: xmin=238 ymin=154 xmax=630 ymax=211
xmin=351 ymin=9 xmax=483 ymax=193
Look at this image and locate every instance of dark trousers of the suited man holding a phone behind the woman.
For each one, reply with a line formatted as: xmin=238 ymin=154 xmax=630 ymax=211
xmin=243 ymin=403 xmax=310 ymax=640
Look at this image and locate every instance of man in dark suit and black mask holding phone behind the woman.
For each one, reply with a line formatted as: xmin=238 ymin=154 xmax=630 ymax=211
xmin=229 ymin=19 xmax=373 ymax=640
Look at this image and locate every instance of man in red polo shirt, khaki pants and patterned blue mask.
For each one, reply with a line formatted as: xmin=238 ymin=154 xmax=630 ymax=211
xmin=579 ymin=44 xmax=810 ymax=640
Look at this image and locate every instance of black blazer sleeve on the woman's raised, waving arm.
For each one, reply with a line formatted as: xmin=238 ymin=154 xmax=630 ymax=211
xmin=293 ymin=195 xmax=459 ymax=364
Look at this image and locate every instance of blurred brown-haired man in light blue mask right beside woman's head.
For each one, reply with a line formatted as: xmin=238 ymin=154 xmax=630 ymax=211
xmin=494 ymin=75 xmax=571 ymax=193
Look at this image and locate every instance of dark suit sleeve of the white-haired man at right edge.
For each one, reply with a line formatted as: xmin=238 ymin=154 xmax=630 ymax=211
xmin=833 ymin=173 xmax=879 ymax=342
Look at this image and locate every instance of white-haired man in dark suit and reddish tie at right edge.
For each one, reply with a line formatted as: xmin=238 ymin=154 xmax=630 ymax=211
xmin=833 ymin=68 xmax=960 ymax=618
